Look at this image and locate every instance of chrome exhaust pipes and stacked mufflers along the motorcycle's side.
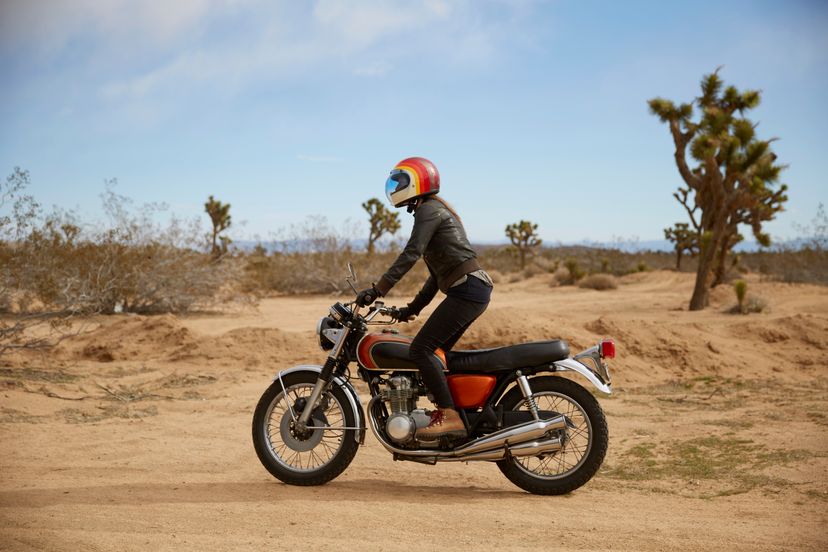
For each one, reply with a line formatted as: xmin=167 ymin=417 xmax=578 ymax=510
xmin=367 ymin=395 xmax=567 ymax=462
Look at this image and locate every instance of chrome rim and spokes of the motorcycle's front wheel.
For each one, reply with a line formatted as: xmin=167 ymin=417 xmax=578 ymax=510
xmin=263 ymin=383 xmax=346 ymax=472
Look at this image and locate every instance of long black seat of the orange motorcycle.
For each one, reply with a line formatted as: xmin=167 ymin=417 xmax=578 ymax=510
xmin=446 ymin=339 xmax=569 ymax=372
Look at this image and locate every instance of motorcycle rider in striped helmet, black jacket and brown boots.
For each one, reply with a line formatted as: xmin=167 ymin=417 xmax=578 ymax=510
xmin=357 ymin=157 xmax=493 ymax=441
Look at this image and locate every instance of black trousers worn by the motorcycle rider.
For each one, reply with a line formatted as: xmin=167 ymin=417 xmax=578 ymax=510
xmin=409 ymin=295 xmax=489 ymax=408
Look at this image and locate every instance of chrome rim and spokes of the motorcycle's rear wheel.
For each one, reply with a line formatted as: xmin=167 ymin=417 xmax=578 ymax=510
xmin=513 ymin=391 xmax=592 ymax=479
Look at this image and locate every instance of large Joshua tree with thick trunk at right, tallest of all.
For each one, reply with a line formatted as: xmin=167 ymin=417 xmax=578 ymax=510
xmin=649 ymin=69 xmax=788 ymax=310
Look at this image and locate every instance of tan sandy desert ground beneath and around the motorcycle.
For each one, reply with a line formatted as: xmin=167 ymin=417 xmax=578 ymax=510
xmin=0 ymin=272 xmax=828 ymax=551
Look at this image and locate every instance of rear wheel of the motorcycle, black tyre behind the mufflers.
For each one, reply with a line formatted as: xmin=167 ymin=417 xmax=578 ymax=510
xmin=497 ymin=376 xmax=609 ymax=495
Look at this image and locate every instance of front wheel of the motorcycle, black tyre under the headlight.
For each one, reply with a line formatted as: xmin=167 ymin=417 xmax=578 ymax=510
xmin=253 ymin=372 xmax=359 ymax=485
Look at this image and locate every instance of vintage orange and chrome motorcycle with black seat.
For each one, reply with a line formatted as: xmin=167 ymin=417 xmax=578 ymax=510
xmin=253 ymin=263 xmax=615 ymax=495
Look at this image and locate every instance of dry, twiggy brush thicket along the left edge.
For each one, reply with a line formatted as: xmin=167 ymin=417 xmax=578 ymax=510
xmin=0 ymin=178 xmax=243 ymax=314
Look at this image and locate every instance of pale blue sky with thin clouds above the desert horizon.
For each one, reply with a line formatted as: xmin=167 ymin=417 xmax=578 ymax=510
xmin=0 ymin=0 xmax=828 ymax=243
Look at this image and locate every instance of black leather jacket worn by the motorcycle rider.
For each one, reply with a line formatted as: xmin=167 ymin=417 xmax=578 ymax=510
xmin=376 ymin=197 xmax=480 ymax=314
